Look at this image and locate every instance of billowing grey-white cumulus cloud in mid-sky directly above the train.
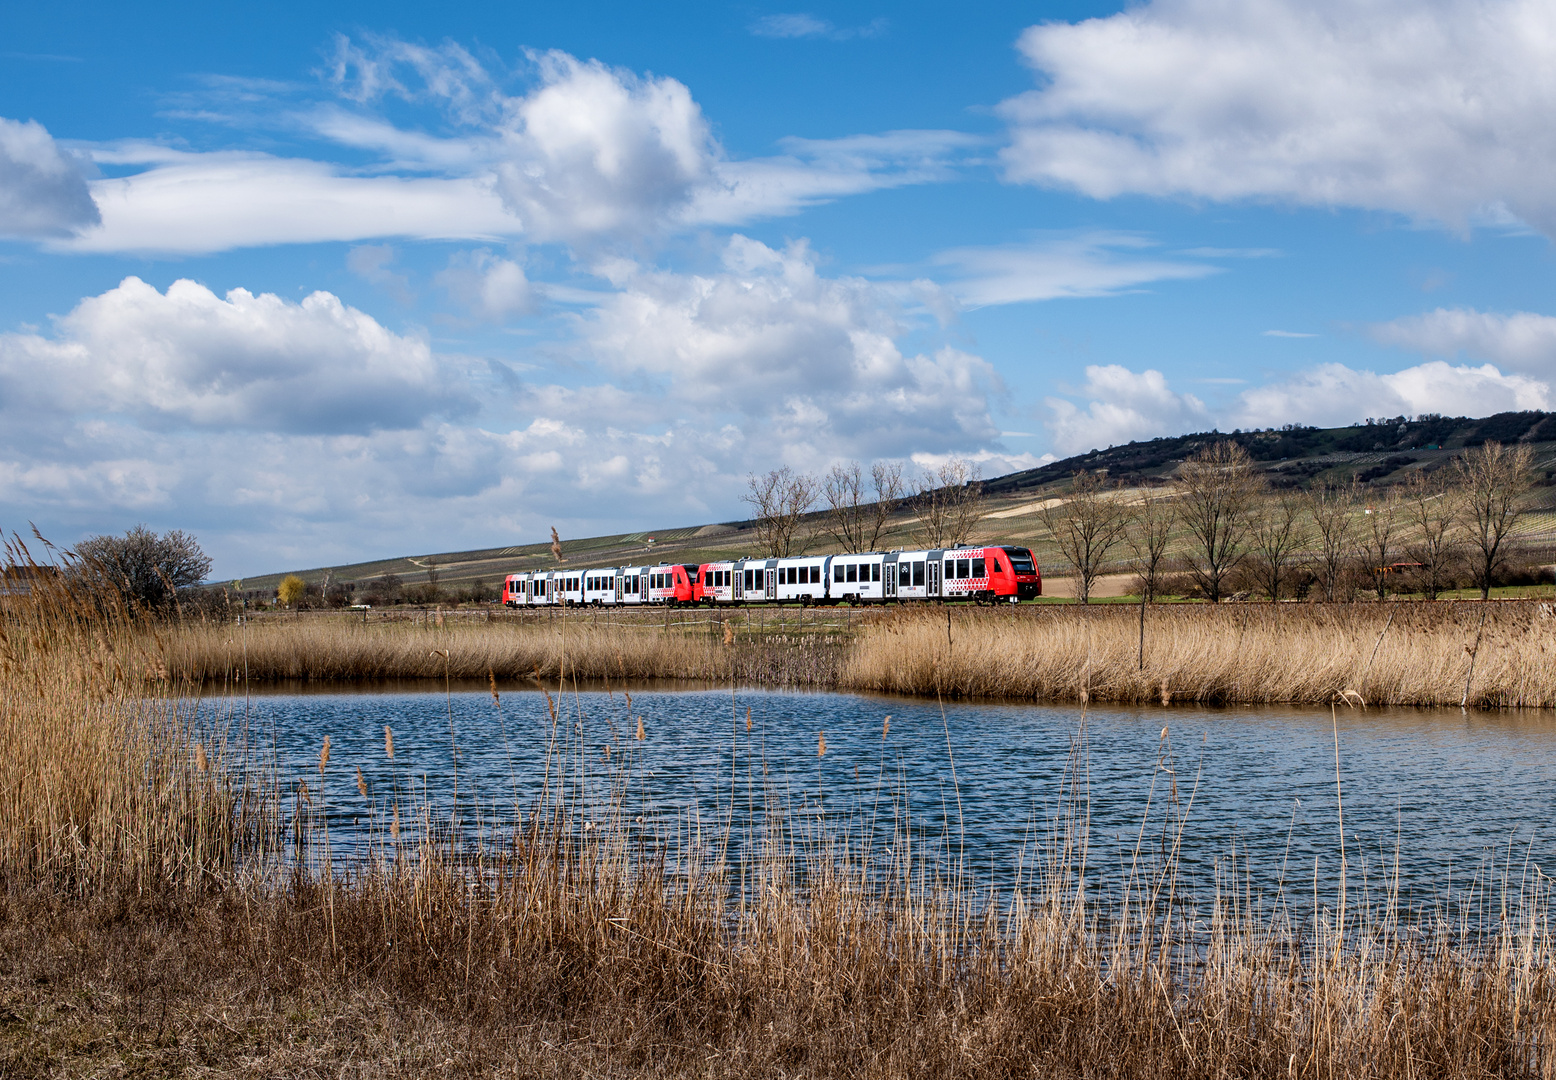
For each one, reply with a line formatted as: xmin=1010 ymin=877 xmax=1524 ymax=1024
xmin=584 ymin=235 xmax=1002 ymax=465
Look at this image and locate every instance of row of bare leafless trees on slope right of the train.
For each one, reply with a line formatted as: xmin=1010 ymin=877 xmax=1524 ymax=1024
xmin=1039 ymin=440 xmax=1533 ymax=604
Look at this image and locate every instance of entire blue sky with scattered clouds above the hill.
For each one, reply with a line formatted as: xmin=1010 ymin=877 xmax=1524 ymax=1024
xmin=0 ymin=0 xmax=1556 ymax=579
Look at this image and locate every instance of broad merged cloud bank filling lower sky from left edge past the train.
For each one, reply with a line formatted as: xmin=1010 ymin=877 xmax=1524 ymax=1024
xmin=0 ymin=259 xmax=1038 ymax=576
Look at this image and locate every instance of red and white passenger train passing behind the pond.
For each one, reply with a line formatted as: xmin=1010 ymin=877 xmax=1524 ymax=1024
xmin=503 ymin=546 xmax=1043 ymax=607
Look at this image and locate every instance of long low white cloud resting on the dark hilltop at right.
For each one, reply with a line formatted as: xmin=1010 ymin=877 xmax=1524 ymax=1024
xmin=1223 ymin=359 xmax=1556 ymax=428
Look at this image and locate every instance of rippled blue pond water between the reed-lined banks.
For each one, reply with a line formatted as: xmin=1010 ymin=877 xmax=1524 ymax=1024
xmin=201 ymin=683 xmax=1556 ymax=906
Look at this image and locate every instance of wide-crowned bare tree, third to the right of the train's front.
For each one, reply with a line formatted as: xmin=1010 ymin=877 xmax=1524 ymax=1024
xmin=1176 ymin=442 xmax=1263 ymax=604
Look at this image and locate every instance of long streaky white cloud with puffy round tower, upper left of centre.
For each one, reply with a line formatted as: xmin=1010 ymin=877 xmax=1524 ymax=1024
xmin=60 ymin=39 xmax=982 ymax=254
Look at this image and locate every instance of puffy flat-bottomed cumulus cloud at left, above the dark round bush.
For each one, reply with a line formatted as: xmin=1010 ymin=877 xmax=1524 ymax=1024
xmin=0 ymin=277 xmax=470 ymax=433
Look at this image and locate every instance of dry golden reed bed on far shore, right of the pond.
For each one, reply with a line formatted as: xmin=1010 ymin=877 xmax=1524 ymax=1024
xmin=840 ymin=602 xmax=1556 ymax=708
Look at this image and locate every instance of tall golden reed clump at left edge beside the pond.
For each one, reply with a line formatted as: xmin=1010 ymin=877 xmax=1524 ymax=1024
xmin=0 ymin=540 xmax=241 ymax=889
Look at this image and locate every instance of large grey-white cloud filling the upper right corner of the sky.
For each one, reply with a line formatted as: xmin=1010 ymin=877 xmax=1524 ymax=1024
xmin=1001 ymin=0 xmax=1556 ymax=235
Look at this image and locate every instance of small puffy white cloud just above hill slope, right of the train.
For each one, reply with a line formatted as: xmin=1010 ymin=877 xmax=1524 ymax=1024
xmin=1047 ymin=364 xmax=1211 ymax=454
